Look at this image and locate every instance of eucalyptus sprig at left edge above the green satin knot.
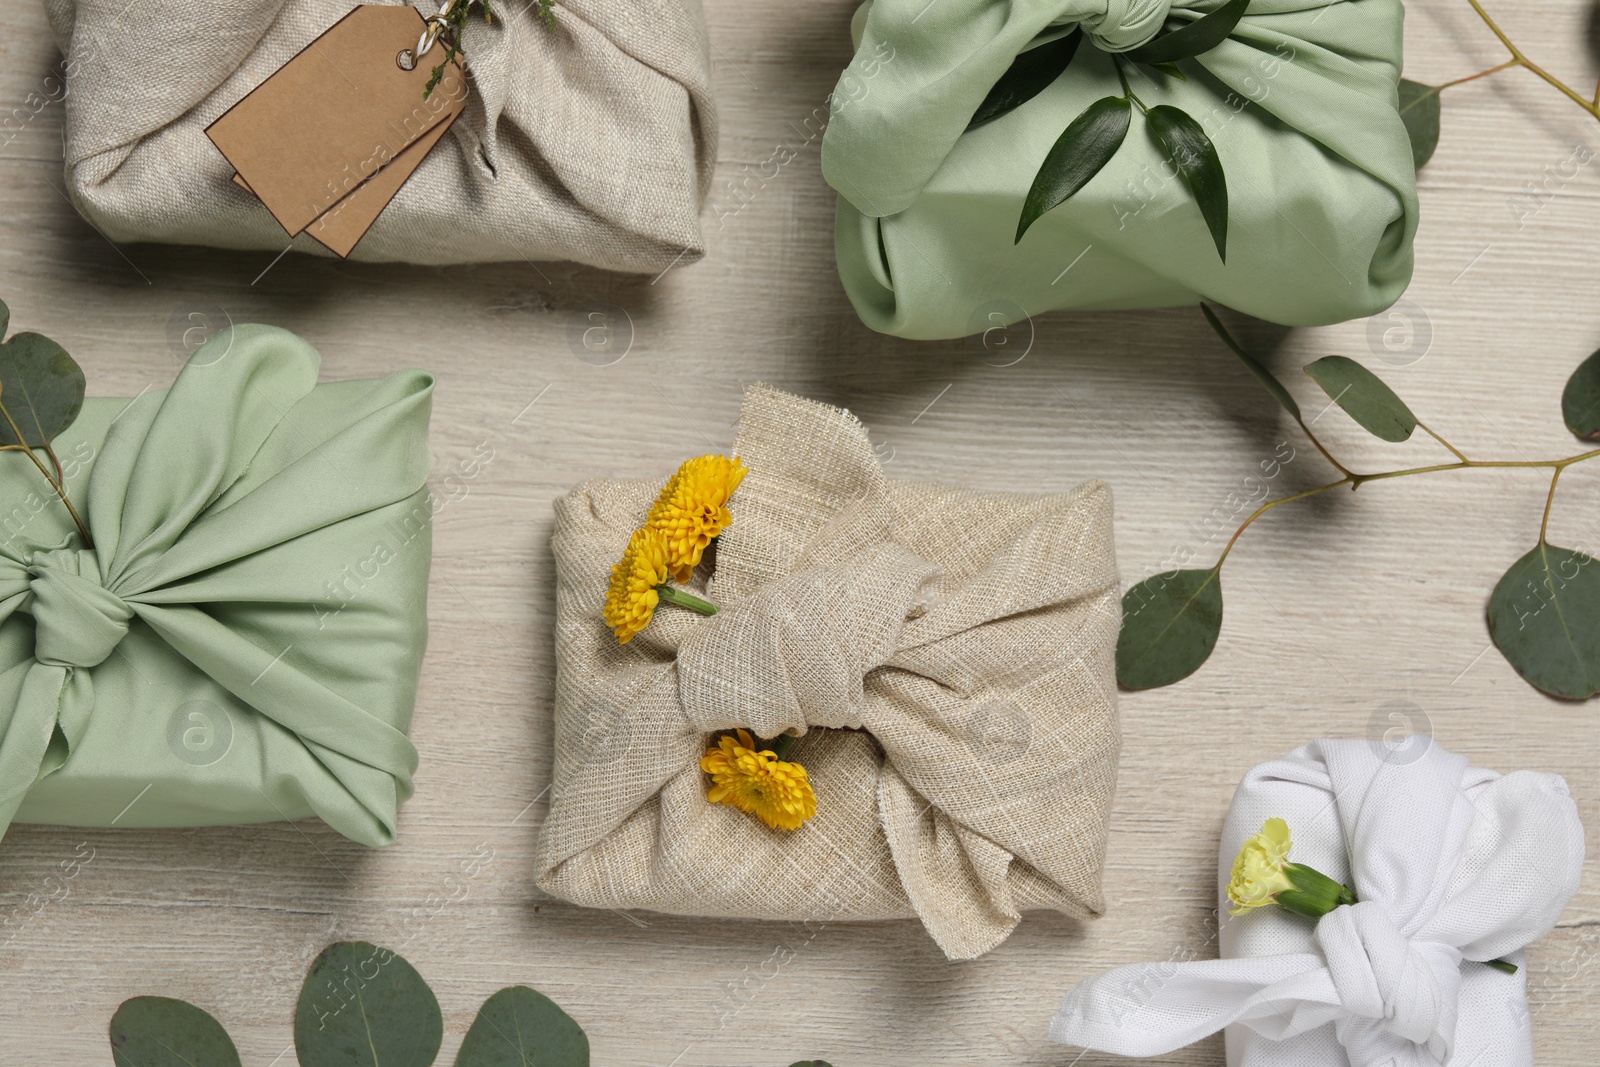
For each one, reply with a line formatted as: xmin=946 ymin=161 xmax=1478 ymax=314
xmin=0 ymin=302 xmax=94 ymax=549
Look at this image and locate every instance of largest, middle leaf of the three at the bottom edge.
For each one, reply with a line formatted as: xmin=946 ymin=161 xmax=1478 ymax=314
xmin=294 ymin=941 xmax=445 ymax=1067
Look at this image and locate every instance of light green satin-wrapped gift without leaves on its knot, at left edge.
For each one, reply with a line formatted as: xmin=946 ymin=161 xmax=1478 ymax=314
xmin=0 ymin=326 xmax=434 ymax=846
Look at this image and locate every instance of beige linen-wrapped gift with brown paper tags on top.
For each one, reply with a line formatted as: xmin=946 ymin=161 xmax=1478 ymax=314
xmin=45 ymin=0 xmax=717 ymax=274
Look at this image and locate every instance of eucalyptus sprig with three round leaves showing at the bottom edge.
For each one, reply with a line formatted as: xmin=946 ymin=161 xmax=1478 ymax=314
xmin=110 ymin=941 xmax=829 ymax=1067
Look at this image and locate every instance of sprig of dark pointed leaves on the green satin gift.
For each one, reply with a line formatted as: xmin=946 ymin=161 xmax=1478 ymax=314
xmin=966 ymin=0 xmax=1250 ymax=262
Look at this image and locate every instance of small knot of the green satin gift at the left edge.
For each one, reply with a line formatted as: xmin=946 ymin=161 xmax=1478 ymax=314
xmin=27 ymin=549 xmax=133 ymax=667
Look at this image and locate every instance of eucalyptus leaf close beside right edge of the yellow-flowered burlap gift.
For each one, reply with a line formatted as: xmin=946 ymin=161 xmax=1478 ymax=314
xmin=1117 ymin=568 xmax=1222 ymax=689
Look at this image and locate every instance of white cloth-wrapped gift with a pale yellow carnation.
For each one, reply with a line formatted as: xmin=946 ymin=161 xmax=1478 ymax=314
xmin=1050 ymin=736 xmax=1584 ymax=1067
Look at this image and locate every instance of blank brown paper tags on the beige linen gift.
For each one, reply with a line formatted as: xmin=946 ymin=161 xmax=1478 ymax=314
xmin=206 ymin=5 xmax=467 ymax=246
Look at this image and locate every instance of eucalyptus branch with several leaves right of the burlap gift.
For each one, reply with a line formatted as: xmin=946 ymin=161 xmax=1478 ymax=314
xmin=1117 ymin=306 xmax=1600 ymax=701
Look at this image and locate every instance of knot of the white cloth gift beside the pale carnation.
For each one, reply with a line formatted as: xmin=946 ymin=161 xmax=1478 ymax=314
xmin=1317 ymin=901 xmax=1461 ymax=1045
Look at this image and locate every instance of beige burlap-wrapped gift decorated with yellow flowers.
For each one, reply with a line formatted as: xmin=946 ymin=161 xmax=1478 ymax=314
xmin=536 ymin=386 xmax=1120 ymax=958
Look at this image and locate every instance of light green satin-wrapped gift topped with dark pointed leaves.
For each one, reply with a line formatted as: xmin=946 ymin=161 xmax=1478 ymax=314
xmin=822 ymin=0 xmax=1418 ymax=339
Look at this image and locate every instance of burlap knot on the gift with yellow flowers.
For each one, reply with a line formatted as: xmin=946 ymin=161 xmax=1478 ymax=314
xmin=677 ymin=544 xmax=941 ymax=737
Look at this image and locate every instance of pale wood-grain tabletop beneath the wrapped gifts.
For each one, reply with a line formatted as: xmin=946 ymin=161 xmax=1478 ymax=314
xmin=0 ymin=0 xmax=1600 ymax=1067
